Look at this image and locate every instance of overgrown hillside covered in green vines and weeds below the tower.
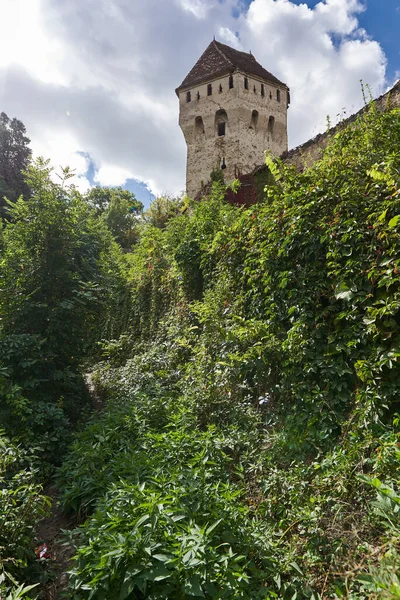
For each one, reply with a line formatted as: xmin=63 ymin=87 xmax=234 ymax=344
xmin=0 ymin=105 xmax=400 ymax=600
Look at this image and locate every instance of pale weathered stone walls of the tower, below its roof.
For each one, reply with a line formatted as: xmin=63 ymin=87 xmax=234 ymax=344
xmin=179 ymin=72 xmax=288 ymax=197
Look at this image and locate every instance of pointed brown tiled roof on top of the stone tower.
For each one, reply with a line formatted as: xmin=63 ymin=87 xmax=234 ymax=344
xmin=175 ymin=40 xmax=287 ymax=94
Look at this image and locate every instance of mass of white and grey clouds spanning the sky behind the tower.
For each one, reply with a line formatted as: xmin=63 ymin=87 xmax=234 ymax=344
xmin=0 ymin=0 xmax=385 ymax=198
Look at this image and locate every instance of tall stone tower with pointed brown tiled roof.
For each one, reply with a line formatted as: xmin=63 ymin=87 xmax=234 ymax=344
xmin=176 ymin=40 xmax=290 ymax=197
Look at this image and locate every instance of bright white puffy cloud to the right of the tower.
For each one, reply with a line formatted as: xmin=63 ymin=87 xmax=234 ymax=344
xmin=236 ymin=0 xmax=386 ymax=147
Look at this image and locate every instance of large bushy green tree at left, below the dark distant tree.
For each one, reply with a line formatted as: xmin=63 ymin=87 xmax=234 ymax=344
xmin=0 ymin=160 xmax=125 ymax=454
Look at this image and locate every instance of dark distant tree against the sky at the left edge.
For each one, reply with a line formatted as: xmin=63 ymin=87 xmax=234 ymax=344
xmin=0 ymin=112 xmax=31 ymax=216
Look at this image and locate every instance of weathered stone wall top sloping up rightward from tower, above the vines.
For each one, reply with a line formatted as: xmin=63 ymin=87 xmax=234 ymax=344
xmin=281 ymin=81 xmax=400 ymax=171
